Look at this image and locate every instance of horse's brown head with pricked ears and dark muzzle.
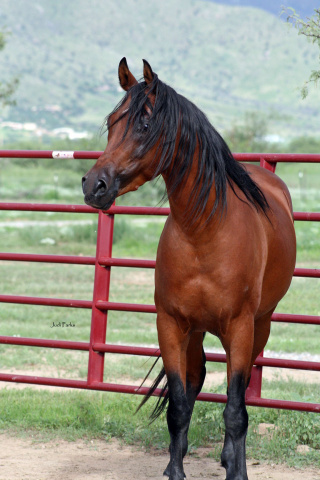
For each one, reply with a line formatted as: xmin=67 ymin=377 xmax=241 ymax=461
xmin=82 ymin=58 xmax=157 ymax=210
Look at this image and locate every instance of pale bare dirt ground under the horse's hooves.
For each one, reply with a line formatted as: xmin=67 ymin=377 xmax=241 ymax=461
xmin=0 ymin=434 xmax=320 ymax=480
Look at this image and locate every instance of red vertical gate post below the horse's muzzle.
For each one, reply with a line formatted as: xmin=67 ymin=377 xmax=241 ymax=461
xmin=87 ymin=211 xmax=114 ymax=385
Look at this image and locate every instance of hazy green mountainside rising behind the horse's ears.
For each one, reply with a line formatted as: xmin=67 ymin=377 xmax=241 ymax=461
xmin=0 ymin=0 xmax=320 ymax=139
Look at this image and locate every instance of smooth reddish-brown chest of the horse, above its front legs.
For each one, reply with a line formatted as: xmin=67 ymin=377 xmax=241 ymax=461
xmin=155 ymin=221 xmax=252 ymax=335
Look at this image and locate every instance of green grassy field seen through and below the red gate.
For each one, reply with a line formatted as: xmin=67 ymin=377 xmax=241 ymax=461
xmin=0 ymin=158 xmax=320 ymax=465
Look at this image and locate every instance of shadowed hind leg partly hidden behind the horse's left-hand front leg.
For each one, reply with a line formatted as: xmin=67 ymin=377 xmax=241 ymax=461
xmin=163 ymin=332 xmax=206 ymax=477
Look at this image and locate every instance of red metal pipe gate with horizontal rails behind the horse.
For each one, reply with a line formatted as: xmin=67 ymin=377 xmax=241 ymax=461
xmin=0 ymin=150 xmax=320 ymax=412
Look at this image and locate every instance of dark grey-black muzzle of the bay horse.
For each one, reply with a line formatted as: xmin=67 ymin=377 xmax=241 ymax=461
xmin=82 ymin=171 xmax=120 ymax=210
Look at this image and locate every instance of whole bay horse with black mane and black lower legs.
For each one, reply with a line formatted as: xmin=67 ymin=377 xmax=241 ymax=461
xmin=82 ymin=58 xmax=296 ymax=480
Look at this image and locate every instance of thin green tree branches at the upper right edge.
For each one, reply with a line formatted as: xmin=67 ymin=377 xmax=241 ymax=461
xmin=282 ymin=7 xmax=320 ymax=98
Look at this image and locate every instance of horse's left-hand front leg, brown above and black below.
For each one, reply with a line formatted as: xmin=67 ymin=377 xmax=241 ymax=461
xmin=157 ymin=313 xmax=192 ymax=480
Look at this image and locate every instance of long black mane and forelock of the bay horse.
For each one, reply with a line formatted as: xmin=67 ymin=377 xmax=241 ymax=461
xmin=107 ymin=74 xmax=269 ymax=221
